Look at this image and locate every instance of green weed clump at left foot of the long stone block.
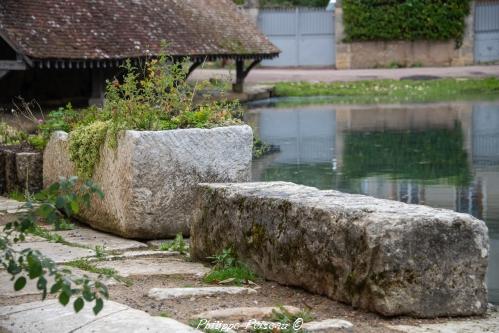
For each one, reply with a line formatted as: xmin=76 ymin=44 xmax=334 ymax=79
xmin=203 ymin=249 xmax=256 ymax=285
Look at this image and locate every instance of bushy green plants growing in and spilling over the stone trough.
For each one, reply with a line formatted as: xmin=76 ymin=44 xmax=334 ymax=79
xmin=69 ymin=55 xmax=243 ymax=177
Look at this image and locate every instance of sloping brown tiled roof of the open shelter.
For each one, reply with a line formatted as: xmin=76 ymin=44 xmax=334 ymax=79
xmin=0 ymin=0 xmax=279 ymax=61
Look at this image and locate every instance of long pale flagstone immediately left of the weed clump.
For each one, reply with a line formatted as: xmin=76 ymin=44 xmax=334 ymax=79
xmin=95 ymin=258 xmax=209 ymax=277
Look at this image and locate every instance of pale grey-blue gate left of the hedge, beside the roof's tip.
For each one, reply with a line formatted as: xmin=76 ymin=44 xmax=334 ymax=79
xmin=258 ymin=8 xmax=336 ymax=67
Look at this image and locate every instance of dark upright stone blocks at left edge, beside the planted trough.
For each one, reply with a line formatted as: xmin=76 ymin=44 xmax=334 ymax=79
xmin=0 ymin=146 xmax=43 ymax=194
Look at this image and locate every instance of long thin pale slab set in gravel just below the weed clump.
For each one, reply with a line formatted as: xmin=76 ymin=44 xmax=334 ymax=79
xmin=147 ymin=287 xmax=256 ymax=301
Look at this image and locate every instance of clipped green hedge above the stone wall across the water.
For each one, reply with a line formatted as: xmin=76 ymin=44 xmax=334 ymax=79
xmin=343 ymin=0 xmax=471 ymax=46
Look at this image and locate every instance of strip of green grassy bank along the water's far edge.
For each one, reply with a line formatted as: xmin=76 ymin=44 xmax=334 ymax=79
xmin=275 ymin=78 xmax=499 ymax=103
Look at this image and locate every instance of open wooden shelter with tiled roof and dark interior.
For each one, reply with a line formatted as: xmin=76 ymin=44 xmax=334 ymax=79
xmin=0 ymin=0 xmax=279 ymax=104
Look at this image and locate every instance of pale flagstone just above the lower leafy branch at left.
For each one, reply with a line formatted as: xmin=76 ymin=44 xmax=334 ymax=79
xmin=12 ymin=242 xmax=95 ymax=264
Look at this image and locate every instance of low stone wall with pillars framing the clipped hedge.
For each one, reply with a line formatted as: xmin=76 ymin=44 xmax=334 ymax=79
xmin=335 ymin=1 xmax=475 ymax=69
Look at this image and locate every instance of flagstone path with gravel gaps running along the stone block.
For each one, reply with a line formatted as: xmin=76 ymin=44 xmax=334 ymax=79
xmin=0 ymin=197 xmax=499 ymax=333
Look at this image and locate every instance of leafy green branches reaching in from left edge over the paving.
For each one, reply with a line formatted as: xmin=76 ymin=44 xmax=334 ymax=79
xmin=0 ymin=177 xmax=108 ymax=314
